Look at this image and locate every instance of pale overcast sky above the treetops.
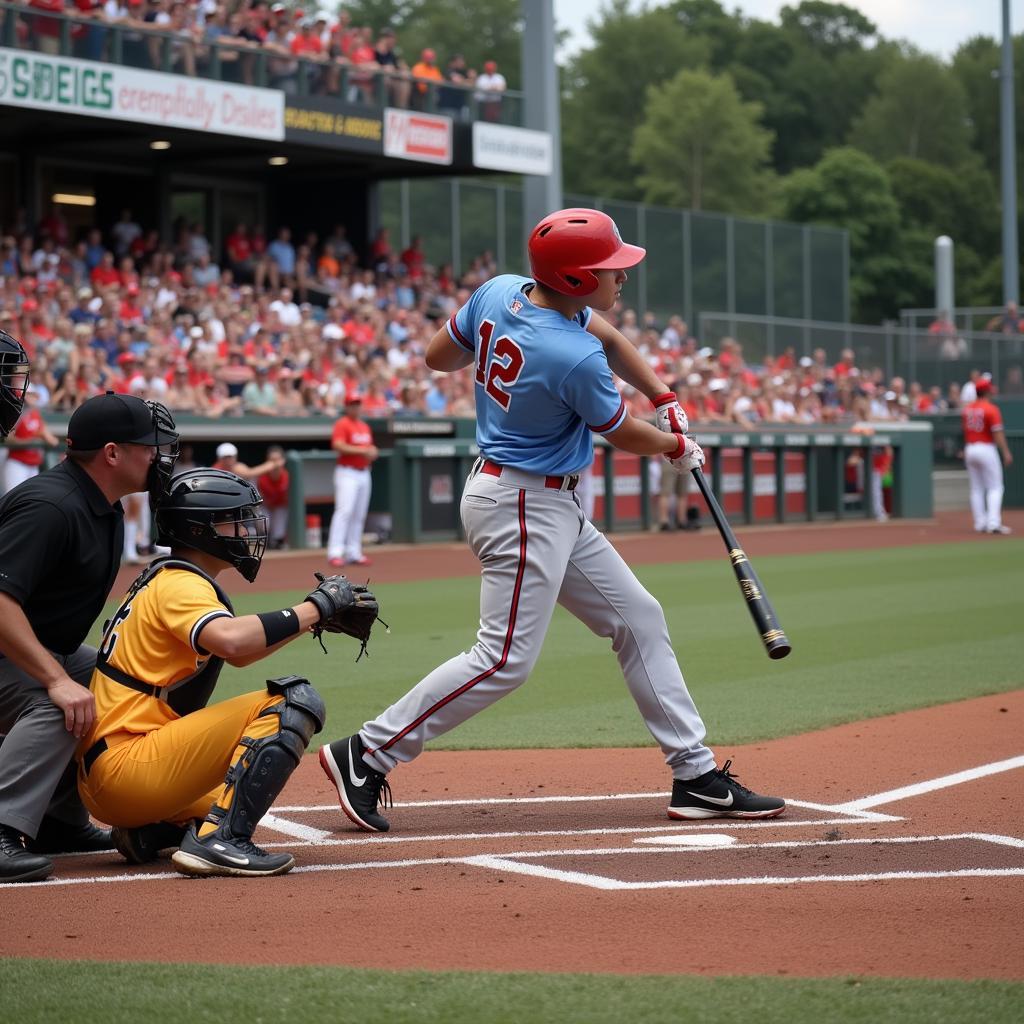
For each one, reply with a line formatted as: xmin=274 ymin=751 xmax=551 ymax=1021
xmin=554 ymin=0 xmax=1024 ymax=59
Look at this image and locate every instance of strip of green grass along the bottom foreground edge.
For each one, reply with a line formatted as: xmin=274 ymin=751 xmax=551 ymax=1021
xmin=0 ymin=961 xmax=1024 ymax=1024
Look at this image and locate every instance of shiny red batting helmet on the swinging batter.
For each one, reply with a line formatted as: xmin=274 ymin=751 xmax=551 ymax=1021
xmin=528 ymin=208 xmax=647 ymax=296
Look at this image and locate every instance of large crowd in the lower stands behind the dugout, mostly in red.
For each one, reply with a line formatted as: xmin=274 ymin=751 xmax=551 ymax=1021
xmin=0 ymin=206 xmax=999 ymax=448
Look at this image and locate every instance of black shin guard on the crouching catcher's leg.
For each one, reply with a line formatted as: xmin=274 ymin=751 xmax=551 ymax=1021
xmin=207 ymin=676 xmax=325 ymax=839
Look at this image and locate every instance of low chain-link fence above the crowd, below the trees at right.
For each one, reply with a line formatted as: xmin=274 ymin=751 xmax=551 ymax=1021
xmin=697 ymin=312 xmax=1024 ymax=394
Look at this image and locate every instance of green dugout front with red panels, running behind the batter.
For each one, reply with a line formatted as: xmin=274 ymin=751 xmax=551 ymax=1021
xmin=28 ymin=416 xmax=937 ymax=549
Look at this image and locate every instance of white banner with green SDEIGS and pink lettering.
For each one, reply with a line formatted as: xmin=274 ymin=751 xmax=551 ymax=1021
xmin=0 ymin=47 xmax=285 ymax=141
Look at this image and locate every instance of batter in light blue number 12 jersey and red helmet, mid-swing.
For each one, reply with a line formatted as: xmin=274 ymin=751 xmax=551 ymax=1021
xmin=319 ymin=209 xmax=785 ymax=831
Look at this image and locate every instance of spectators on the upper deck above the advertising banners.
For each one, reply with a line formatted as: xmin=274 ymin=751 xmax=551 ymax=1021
xmin=14 ymin=0 xmax=507 ymax=121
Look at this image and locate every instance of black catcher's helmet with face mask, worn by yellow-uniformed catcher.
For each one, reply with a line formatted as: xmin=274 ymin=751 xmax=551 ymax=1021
xmin=157 ymin=469 xmax=266 ymax=583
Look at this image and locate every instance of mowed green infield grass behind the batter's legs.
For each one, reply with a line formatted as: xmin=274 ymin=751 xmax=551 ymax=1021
xmin=94 ymin=540 xmax=1024 ymax=750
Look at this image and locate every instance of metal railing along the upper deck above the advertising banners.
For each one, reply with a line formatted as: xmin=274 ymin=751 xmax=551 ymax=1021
xmin=0 ymin=0 xmax=523 ymax=125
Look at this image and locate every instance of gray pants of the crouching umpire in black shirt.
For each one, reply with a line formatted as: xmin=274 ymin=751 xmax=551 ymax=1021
xmin=0 ymin=644 xmax=96 ymax=839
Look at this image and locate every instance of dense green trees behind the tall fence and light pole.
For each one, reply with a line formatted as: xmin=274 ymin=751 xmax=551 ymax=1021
xmin=346 ymin=0 xmax=1024 ymax=322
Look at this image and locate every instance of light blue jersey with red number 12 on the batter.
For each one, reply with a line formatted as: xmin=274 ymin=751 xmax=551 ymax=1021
xmin=447 ymin=273 xmax=627 ymax=475
